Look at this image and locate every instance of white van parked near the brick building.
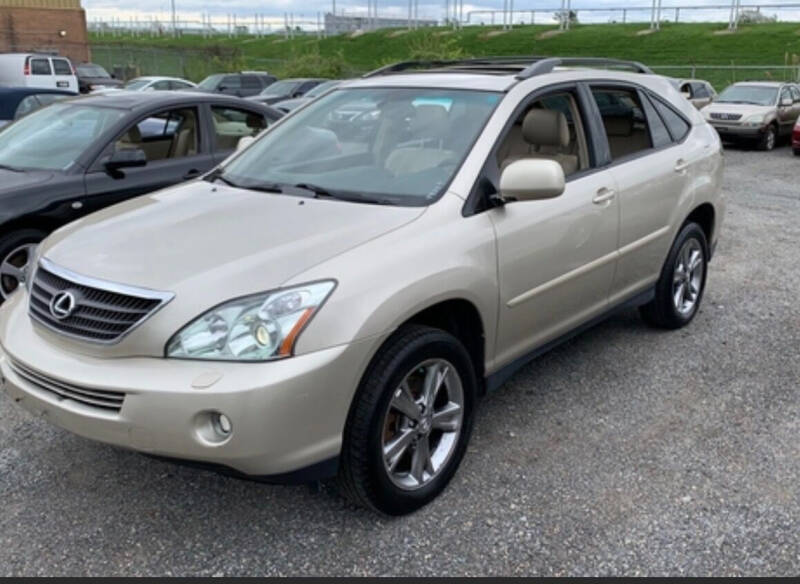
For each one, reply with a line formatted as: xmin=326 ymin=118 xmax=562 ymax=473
xmin=0 ymin=53 xmax=78 ymax=93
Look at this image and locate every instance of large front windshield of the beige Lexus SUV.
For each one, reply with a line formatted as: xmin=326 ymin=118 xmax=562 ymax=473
xmin=216 ymin=88 xmax=501 ymax=206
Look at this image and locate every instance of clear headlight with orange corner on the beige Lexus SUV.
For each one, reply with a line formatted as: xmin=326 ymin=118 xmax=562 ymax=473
xmin=166 ymin=280 xmax=336 ymax=361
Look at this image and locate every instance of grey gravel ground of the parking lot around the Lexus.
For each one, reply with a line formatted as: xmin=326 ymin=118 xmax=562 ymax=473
xmin=0 ymin=147 xmax=800 ymax=576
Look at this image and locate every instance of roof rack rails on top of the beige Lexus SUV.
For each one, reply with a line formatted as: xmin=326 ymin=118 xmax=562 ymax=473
xmin=363 ymin=56 xmax=653 ymax=79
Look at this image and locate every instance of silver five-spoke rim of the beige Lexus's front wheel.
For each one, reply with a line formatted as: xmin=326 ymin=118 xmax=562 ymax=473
xmin=381 ymin=359 xmax=464 ymax=490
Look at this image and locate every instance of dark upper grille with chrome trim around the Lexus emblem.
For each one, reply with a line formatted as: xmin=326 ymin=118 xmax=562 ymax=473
xmin=28 ymin=259 xmax=173 ymax=343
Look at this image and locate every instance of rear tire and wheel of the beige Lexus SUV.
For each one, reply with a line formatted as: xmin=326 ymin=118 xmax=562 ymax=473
xmin=639 ymin=222 xmax=709 ymax=329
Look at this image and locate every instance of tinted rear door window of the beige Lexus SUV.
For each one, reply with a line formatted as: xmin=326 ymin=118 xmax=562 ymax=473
xmin=592 ymin=88 xmax=653 ymax=160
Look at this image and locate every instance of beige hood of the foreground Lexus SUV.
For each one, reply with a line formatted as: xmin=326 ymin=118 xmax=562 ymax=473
xmin=42 ymin=181 xmax=424 ymax=296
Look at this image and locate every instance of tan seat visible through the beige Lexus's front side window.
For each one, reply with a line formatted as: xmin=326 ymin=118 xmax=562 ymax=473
xmin=500 ymin=109 xmax=580 ymax=176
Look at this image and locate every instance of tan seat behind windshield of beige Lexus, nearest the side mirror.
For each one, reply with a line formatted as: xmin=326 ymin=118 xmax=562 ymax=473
xmin=384 ymin=105 xmax=455 ymax=175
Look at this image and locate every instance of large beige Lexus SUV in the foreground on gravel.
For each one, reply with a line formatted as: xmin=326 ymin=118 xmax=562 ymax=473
xmin=0 ymin=58 xmax=725 ymax=514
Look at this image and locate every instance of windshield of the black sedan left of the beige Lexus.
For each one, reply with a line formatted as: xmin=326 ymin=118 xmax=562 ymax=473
xmin=0 ymin=104 xmax=125 ymax=170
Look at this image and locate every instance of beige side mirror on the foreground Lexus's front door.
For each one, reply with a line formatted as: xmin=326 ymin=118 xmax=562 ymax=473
xmin=500 ymin=159 xmax=566 ymax=201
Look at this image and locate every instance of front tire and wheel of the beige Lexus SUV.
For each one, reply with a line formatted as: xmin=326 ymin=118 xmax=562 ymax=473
xmin=338 ymin=325 xmax=478 ymax=515
